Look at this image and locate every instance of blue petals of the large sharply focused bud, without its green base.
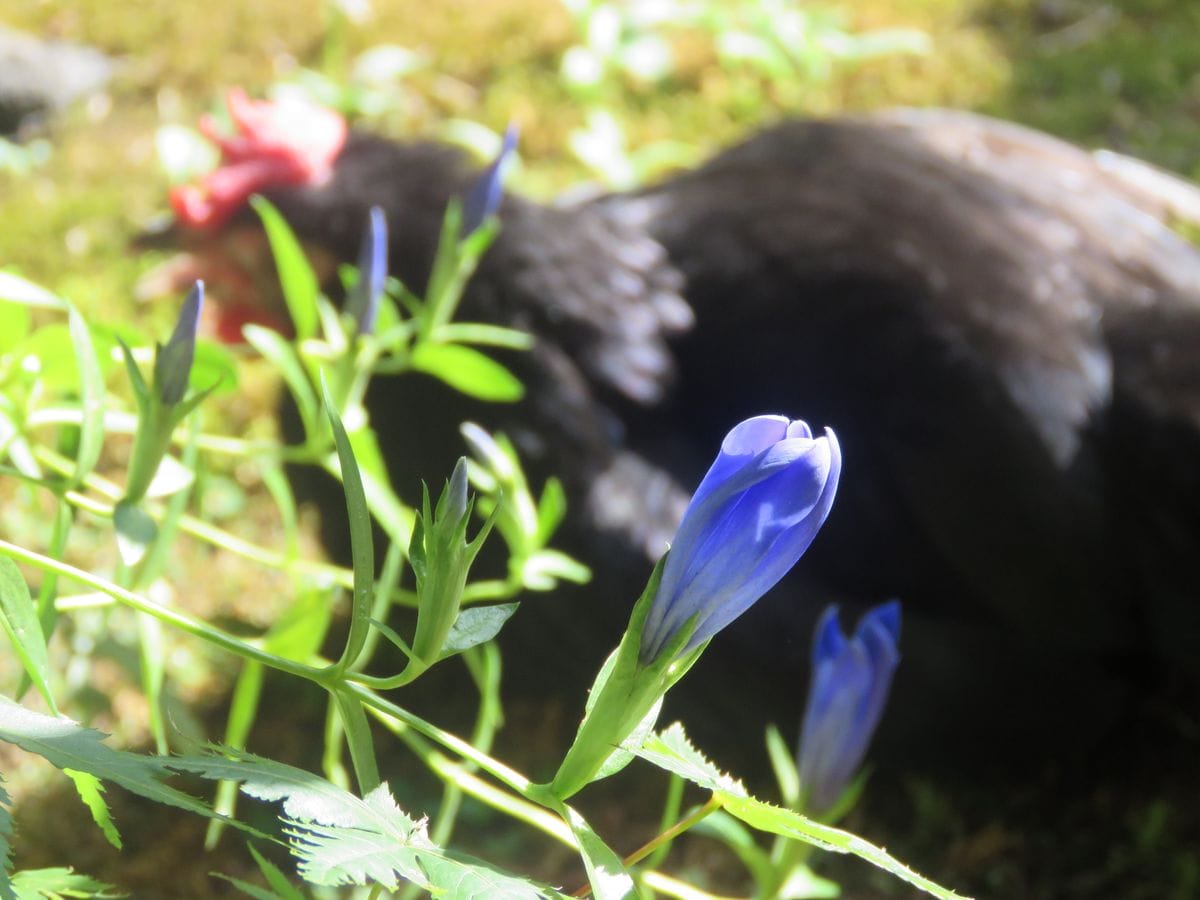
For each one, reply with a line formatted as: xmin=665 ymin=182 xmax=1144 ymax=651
xmin=640 ymin=415 xmax=841 ymax=662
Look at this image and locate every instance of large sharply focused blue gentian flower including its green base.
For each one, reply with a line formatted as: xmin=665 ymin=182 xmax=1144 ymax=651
xmin=547 ymin=415 xmax=841 ymax=799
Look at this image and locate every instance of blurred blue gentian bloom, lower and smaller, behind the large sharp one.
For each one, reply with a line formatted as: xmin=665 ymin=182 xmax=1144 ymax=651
xmin=797 ymin=600 xmax=900 ymax=812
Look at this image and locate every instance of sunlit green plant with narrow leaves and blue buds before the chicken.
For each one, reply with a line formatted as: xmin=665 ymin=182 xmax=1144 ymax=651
xmin=0 ymin=168 xmax=955 ymax=900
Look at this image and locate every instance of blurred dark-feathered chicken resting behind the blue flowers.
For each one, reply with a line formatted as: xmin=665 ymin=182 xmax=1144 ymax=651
xmin=154 ymin=95 xmax=1200 ymax=763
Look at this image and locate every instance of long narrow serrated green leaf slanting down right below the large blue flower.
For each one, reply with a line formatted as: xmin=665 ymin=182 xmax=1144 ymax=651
xmin=637 ymin=722 xmax=961 ymax=900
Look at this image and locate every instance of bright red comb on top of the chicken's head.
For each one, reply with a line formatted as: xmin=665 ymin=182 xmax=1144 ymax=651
xmin=170 ymin=88 xmax=347 ymax=228
